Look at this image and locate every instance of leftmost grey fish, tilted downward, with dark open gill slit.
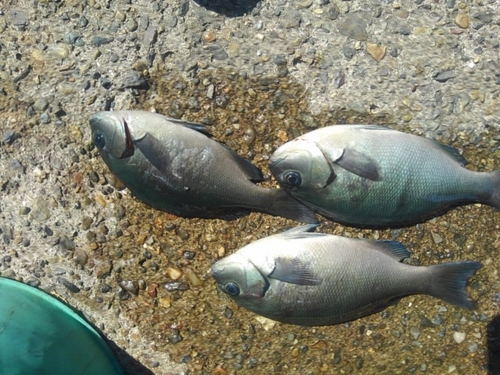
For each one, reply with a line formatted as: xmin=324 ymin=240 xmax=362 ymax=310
xmin=89 ymin=111 xmax=318 ymax=223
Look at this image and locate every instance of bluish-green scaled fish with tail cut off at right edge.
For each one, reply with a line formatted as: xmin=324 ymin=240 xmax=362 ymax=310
xmin=269 ymin=125 xmax=500 ymax=228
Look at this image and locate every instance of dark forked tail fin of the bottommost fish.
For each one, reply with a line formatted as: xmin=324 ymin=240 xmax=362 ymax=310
xmin=429 ymin=261 xmax=482 ymax=310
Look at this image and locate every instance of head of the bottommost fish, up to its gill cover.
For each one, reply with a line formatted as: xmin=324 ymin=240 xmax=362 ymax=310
xmin=211 ymin=253 xmax=269 ymax=305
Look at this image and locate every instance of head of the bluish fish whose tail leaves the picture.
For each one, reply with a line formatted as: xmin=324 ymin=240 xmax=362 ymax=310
xmin=269 ymin=138 xmax=335 ymax=193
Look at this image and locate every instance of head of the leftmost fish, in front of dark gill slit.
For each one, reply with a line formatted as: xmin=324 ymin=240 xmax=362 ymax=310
xmin=89 ymin=111 xmax=134 ymax=159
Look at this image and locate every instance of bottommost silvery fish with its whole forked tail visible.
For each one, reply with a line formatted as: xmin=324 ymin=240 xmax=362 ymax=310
xmin=211 ymin=225 xmax=482 ymax=326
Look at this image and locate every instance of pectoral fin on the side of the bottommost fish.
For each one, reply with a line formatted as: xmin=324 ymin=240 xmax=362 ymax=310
xmin=269 ymin=258 xmax=322 ymax=285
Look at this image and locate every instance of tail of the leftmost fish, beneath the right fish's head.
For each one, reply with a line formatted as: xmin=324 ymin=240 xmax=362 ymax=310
xmin=268 ymin=189 xmax=319 ymax=224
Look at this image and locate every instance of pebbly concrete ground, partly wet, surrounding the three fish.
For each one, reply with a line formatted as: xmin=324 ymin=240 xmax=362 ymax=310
xmin=0 ymin=0 xmax=500 ymax=375
